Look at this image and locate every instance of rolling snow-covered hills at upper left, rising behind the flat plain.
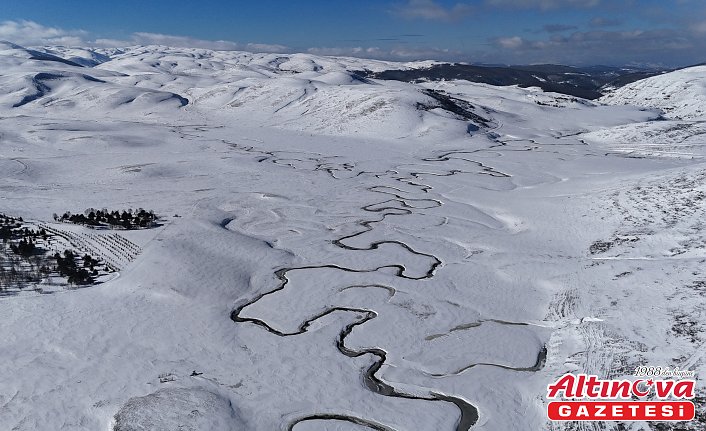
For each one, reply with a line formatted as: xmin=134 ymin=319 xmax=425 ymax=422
xmin=0 ymin=45 xmax=485 ymax=137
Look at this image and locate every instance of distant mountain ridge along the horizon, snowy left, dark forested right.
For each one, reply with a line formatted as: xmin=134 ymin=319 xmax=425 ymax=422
xmin=0 ymin=41 xmax=703 ymax=105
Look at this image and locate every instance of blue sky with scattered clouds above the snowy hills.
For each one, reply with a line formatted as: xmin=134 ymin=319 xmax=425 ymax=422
xmin=0 ymin=0 xmax=706 ymax=66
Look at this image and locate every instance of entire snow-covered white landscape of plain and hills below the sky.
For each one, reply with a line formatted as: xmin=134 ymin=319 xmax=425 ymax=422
xmin=0 ymin=38 xmax=706 ymax=431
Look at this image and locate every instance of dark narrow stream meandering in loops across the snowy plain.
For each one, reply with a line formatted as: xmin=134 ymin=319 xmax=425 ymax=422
xmin=214 ymin=123 xmax=547 ymax=431
